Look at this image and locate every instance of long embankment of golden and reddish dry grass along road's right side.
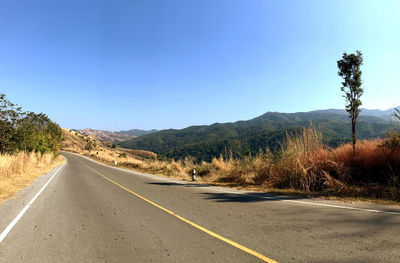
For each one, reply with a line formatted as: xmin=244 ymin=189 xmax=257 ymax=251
xmin=63 ymin=127 xmax=400 ymax=201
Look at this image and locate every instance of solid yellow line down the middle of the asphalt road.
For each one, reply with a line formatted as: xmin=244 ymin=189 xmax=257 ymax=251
xmin=77 ymin=159 xmax=278 ymax=263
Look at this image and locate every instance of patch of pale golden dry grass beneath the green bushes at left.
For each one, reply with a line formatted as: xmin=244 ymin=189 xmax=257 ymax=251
xmin=0 ymin=152 xmax=64 ymax=203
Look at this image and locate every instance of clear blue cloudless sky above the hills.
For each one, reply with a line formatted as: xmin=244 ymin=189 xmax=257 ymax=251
xmin=0 ymin=0 xmax=400 ymax=130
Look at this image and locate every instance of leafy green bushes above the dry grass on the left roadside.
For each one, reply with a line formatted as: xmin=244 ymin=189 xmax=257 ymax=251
xmin=0 ymin=94 xmax=62 ymax=154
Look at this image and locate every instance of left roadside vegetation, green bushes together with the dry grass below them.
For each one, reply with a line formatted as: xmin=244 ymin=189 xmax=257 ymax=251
xmin=0 ymin=94 xmax=63 ymax=202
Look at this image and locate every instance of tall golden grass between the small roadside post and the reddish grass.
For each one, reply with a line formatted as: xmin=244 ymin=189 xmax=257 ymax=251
xmin=202 ymin=126 xmax=341 ymax=191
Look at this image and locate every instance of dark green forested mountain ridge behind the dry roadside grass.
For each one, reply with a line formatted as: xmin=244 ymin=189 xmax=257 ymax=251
xmin=119 ymin=109 xmax=398 ymax=161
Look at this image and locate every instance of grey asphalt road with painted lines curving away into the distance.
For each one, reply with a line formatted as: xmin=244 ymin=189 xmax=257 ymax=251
xmin=0 ymin=153 xmax=400 ymax=262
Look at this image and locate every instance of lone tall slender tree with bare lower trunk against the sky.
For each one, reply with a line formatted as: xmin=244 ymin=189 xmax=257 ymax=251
xmin=337 ymin=50 xmax=364 ymax=153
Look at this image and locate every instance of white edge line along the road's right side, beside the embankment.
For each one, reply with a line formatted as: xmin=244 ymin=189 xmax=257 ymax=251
xmin=61 ymin=151 xmax=400 ymax=218
